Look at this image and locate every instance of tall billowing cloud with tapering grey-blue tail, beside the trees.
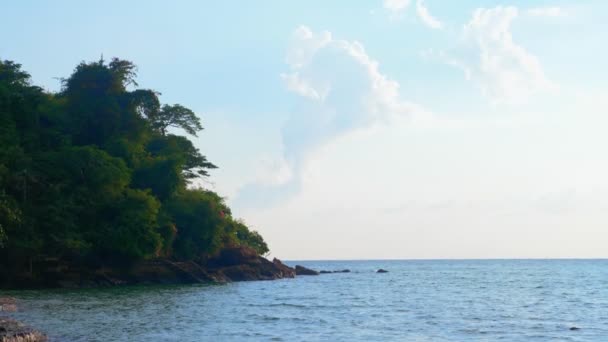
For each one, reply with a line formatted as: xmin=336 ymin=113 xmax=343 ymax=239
xmin=239 ymin=26 xmax=417 ymax=204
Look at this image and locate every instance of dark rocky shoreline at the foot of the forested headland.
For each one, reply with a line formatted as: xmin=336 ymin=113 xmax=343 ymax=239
xmin=0 ymin=247 xmax=296 ymax=289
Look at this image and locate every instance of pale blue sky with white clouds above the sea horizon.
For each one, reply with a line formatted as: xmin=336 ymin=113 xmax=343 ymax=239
xmin=0 ymin=0 xmax=608 ymax=260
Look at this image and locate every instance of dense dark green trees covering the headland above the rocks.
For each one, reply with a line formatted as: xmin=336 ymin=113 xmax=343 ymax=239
xmin=0 ymin=59 xmax=268 ymax=275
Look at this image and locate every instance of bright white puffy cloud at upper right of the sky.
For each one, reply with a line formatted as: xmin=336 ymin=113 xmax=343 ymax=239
xmin=442 ymin=6 xmax=554 ymax=103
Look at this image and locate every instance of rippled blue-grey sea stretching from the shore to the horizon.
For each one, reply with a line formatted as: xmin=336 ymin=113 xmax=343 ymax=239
xmin=4 ymin=260 xmax=608 ymax=341
